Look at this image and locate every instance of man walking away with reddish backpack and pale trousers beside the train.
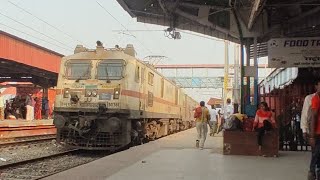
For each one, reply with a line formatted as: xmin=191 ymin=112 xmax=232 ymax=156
xmin=194 ymin=101 xmax=210 ymax=150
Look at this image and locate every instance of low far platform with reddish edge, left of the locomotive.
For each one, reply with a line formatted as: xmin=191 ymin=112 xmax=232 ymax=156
xmin=0 ymin=119 xmax=57 ymax=140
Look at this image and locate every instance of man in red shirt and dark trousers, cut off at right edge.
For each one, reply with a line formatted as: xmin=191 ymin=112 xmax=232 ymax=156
xmin=308 ymin=79 xmax=320 ymax=180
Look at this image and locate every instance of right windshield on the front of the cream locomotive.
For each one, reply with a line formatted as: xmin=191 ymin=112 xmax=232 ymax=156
xmin=97 ymin=60 xmax=123 ymax=80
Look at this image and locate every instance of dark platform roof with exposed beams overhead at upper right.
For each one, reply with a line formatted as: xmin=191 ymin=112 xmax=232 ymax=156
xmin=117 ymin=0 xmax=320 ymax=43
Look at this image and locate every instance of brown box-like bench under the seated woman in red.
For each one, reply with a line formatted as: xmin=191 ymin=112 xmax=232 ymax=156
xmin=223 ymin=131 xmax=279 ymax=156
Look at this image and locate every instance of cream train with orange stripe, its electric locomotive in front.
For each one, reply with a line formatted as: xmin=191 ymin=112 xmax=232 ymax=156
xmin=54 ymin=41 xmax=197 ymax=151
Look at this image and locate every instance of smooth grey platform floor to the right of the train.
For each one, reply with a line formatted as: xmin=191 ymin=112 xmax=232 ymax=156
xmin=45 ymin=128 xmax=311 ymax=180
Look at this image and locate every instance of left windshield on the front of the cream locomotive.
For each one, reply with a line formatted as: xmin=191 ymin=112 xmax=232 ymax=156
xmin=65 ymin=60 xmax=91 ymax=80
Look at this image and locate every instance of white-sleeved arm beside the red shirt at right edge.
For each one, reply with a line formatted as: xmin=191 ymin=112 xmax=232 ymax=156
xmin=300 ymin=93 xmax=315 ymax=140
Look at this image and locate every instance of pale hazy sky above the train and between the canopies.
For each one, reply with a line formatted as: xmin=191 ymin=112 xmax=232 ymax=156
xmin=0 ymin=0 xmax=266 ymax=102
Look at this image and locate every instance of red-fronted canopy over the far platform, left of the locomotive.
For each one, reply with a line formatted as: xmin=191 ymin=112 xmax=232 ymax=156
xmin=0 ymin=30 xmax=63 ymax=87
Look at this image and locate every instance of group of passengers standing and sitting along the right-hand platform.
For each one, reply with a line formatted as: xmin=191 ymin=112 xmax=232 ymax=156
xmin=194 ymin=79 xmax=320 ymax=180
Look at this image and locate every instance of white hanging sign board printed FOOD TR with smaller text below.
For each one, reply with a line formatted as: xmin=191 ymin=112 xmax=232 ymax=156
xmin=268 ymin=37 xmax=320 ymax=68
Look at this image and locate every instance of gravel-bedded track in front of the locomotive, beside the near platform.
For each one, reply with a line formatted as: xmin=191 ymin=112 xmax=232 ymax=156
xmin=0 ymin=149 xmax=108 ymax=180
